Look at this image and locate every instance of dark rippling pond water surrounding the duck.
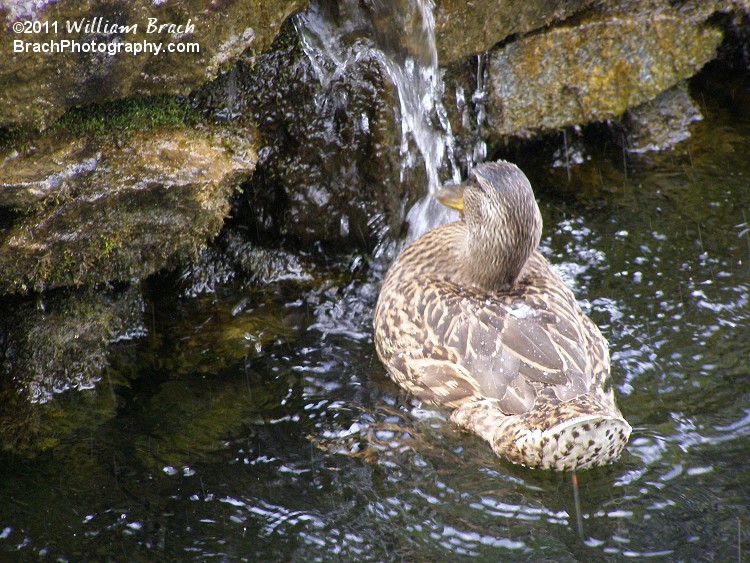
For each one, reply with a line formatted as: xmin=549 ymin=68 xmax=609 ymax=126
xmin=0 ymin=69 xmax=750 ymax=561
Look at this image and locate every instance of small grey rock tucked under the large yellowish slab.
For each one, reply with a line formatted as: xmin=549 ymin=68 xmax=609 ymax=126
xmin=624 ymin=82 xmax=703 ymax=153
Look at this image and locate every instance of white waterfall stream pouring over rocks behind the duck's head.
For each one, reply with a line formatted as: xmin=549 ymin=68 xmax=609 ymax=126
xmin=295 ymin=0 xmax=461 ymax=239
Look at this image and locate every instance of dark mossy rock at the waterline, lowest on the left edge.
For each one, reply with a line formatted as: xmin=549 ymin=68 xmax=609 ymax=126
xmin=0 ymin=287 xmax=146 ymax=451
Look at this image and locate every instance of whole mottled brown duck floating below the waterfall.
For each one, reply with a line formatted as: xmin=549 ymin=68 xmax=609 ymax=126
xmin=373 ymin=160 xmax=631 ymax=471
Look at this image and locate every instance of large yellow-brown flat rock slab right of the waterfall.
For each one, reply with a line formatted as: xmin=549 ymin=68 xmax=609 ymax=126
xmin=487 ymin=12 xmax=722 ymax=137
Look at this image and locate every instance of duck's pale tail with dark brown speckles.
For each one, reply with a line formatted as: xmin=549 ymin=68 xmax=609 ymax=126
xmin=451 ymin=395 xmax=631 ymax=471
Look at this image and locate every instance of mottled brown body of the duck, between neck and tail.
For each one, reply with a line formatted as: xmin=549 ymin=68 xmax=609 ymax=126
xmin=375 ymin=223 xmax=609 ymax=414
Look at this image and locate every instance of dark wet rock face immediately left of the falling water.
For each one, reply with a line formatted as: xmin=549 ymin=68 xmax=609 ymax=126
xmin=198 ymin=22 xmax=424 ymax=248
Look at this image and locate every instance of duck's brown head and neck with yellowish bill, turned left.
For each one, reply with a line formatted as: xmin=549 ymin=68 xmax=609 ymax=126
xmin=437 ymin=161 xmax=542 ymax=290
